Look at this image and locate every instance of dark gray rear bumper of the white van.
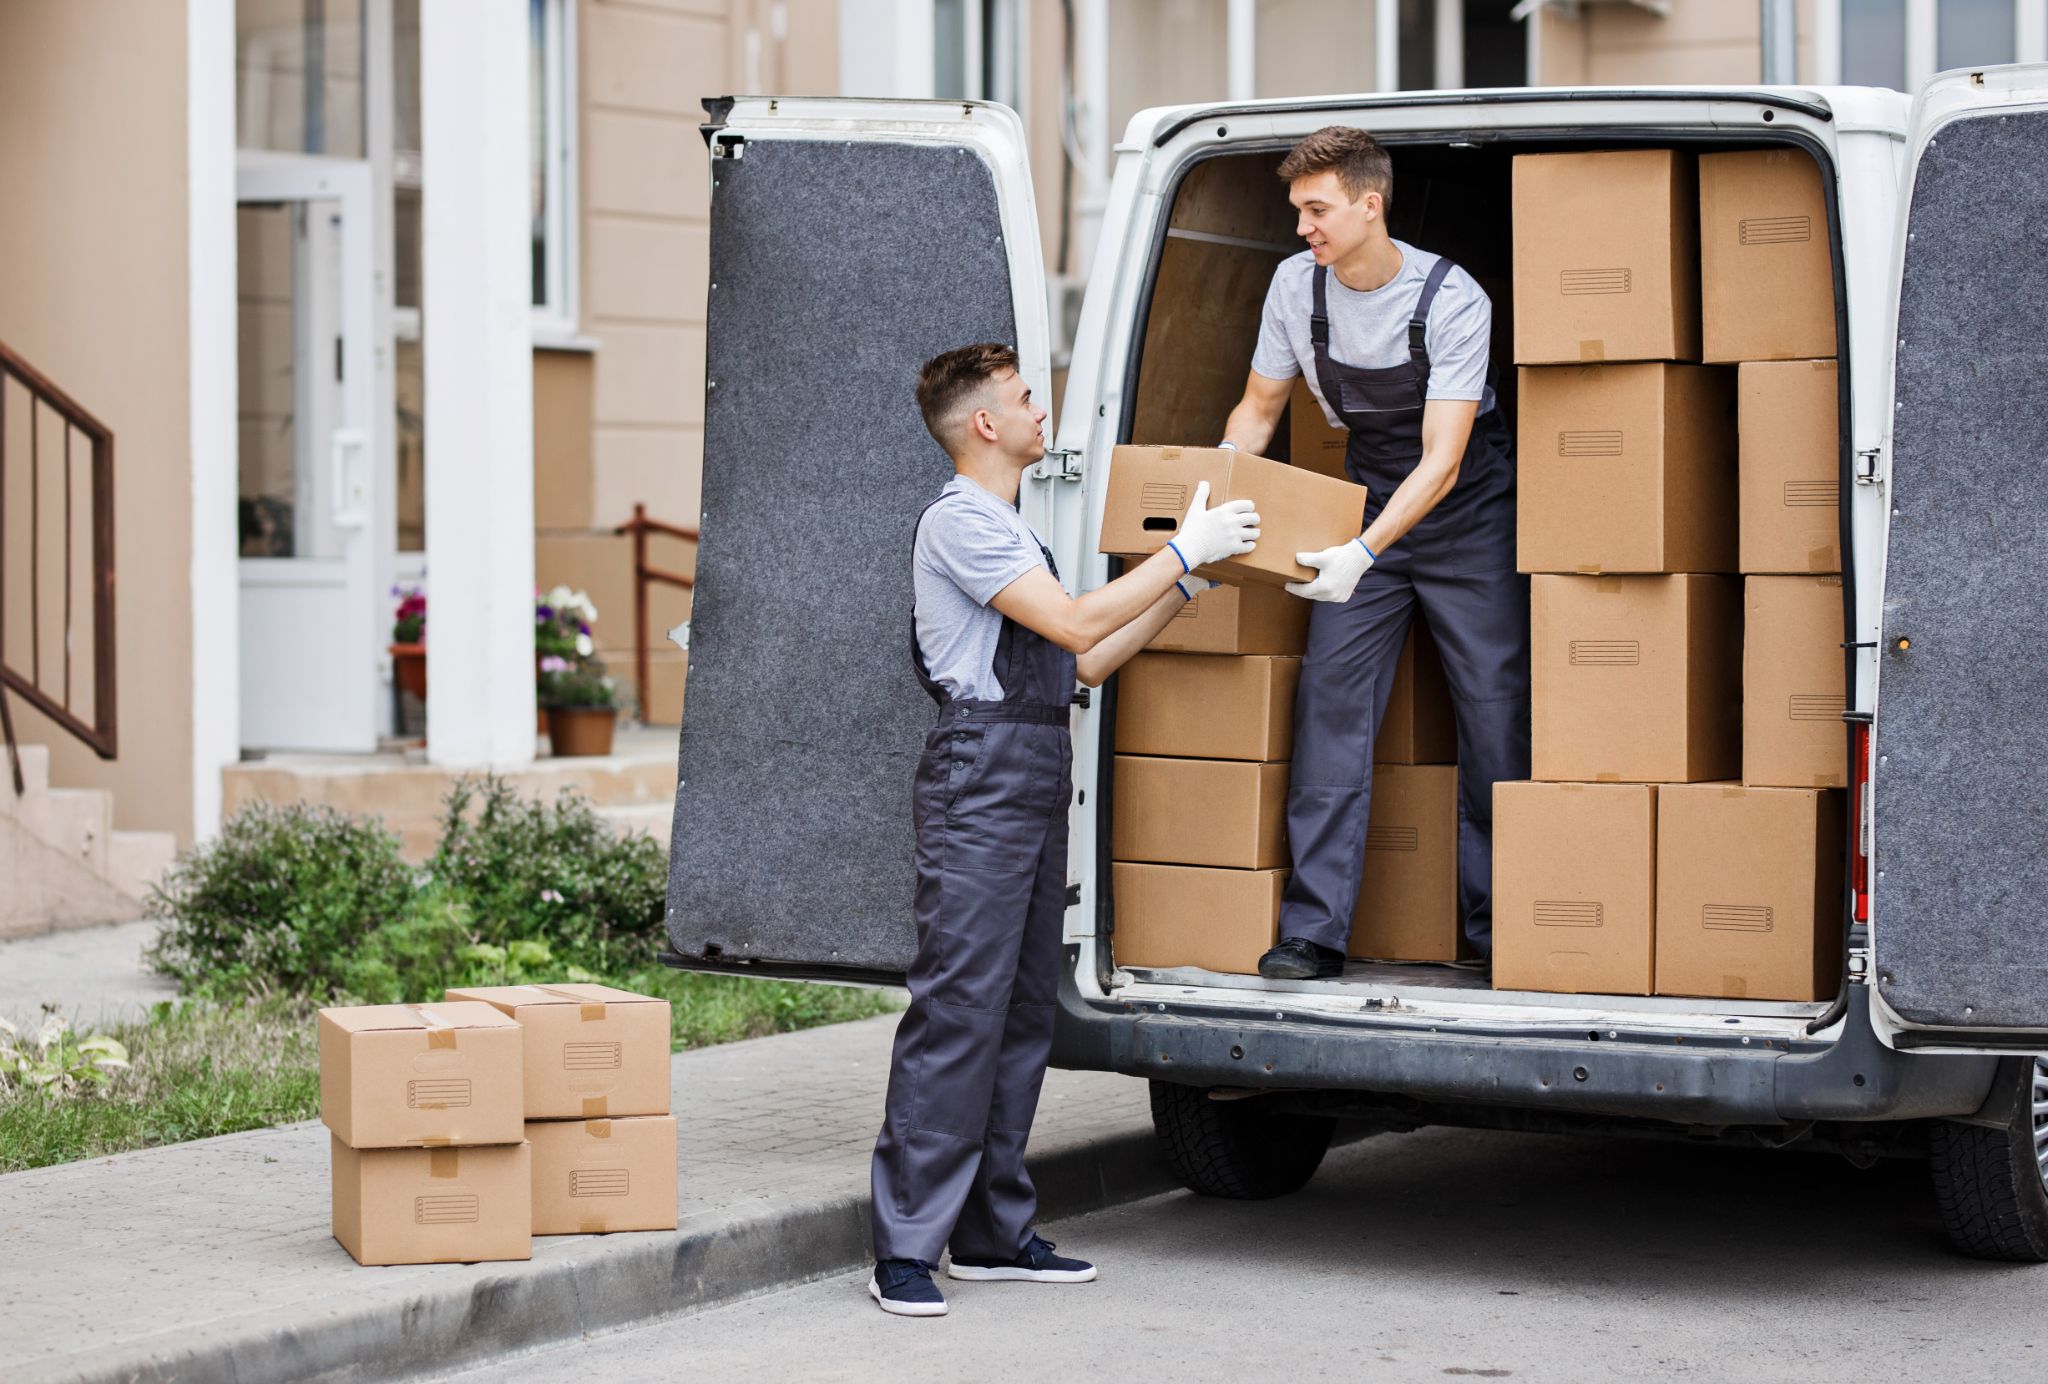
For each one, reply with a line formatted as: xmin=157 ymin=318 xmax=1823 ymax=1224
xmin=1053 ymin=970 xmax=1999 ymax=1126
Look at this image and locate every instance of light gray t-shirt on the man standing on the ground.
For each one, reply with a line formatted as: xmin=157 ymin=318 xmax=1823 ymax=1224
xmin=909 ymin=475 xmax=1044 ymax=702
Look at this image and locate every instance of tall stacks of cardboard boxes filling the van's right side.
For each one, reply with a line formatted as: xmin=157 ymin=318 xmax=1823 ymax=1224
xmin=1493 ymin=149 xmax=1845 ymax=999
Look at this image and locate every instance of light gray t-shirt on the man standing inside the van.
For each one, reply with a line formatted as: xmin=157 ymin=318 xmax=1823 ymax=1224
xmin=1251 ymin=240 xmax=1493 ymax=428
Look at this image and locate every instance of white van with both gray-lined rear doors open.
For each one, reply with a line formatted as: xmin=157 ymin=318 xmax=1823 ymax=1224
xmin=668 ymin=68 xmax=2048 ymax=1261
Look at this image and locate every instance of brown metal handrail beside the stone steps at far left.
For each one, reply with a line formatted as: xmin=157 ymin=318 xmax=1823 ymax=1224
xmin=0 ymin=342 xmax=121 ymax=794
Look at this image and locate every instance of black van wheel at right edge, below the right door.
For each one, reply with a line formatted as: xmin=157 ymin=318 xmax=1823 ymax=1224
xmin=1927 ymin=1056 xmax=2048 ymax=1263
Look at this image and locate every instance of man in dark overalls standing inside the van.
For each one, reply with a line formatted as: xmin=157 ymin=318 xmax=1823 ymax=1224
xmin=1223 ymin=125 xmax=1530 ymax=981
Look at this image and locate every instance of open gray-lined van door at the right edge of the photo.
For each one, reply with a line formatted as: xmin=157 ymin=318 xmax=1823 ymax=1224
xmin=1870 ymin=66 xmax=2048 ymax=1052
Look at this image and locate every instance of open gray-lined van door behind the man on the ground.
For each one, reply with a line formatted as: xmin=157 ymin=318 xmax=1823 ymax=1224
xmin=666 ymin=96 xmax=1051 ymax=981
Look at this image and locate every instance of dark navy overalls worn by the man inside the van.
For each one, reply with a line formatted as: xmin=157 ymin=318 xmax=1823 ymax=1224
xmin=1280 ymin=260 xmax=1530 ymax=956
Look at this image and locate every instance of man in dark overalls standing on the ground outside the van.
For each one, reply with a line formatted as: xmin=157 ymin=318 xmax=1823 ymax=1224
xmin=868 ymin=344 xmax=1260 ymax=1316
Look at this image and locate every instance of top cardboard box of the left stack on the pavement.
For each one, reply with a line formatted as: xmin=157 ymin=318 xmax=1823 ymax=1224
xmin=319 ymin=1003 xmax=524 ymax=1149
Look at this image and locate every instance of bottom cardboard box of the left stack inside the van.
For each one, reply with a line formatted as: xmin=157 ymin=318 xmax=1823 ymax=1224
xmin=1110 ymin=864 xmax=1288 ymax=975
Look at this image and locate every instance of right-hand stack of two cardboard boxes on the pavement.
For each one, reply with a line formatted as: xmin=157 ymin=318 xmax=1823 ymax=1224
xmin=449 ymin=985 xmax=676 ymax=1235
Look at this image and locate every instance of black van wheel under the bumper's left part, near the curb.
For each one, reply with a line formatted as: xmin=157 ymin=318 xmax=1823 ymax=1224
xmin=1151 ymin=1081 xmax=1337 ymax=1202
